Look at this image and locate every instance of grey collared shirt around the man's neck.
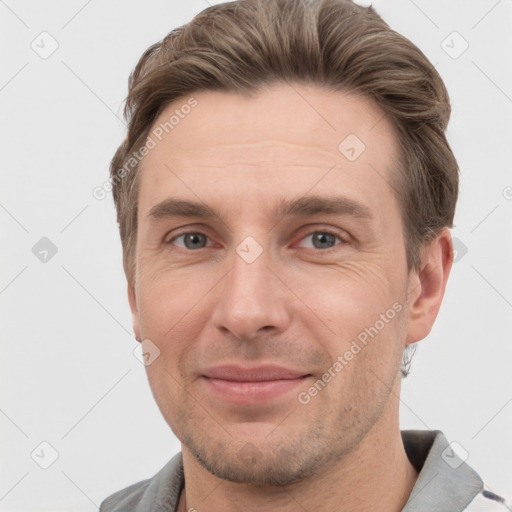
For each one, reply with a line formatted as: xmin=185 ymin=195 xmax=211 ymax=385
xmin=100 ymin=430 xmax=511 ymax=512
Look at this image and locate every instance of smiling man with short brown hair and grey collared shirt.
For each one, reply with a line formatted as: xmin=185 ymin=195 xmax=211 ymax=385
xmin=101 ymin=0 xmax=506 ymax=512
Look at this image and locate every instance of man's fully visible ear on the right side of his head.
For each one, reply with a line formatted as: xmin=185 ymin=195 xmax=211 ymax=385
xmin=405 ymin=228 xmax=453 ymax=345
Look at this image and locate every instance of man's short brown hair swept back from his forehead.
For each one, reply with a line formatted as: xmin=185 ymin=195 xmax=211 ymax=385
xmin=110 ymin=0 xmax=458 ymax=282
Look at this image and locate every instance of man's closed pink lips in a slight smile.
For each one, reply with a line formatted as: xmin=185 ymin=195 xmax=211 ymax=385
xmin=202 ymin=365 xmax=311 ymax=405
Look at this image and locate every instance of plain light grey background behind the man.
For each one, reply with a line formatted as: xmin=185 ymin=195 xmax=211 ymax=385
xmin=0 ymin=0 xmax=512 ymax=512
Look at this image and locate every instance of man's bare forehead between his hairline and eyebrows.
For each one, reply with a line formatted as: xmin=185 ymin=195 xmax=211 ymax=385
xmin=139 ymin=84 xmax=397 ymax=220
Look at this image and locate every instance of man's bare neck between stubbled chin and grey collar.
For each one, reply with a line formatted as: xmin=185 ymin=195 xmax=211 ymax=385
xmin=178 ymin=382 xmax=418 ymax=512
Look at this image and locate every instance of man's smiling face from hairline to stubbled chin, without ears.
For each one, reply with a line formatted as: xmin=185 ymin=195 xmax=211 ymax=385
xmin=129 ymin=85 xmax=409 ymax=485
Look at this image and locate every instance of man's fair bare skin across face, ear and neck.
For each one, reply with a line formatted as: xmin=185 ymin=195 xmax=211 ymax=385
xmin=128 ymin=84 xmax=452 ymax=512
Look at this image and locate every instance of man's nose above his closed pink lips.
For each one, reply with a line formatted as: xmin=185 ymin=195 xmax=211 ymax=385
xmin=213 ymin=243 xmax=293 ymax=340
